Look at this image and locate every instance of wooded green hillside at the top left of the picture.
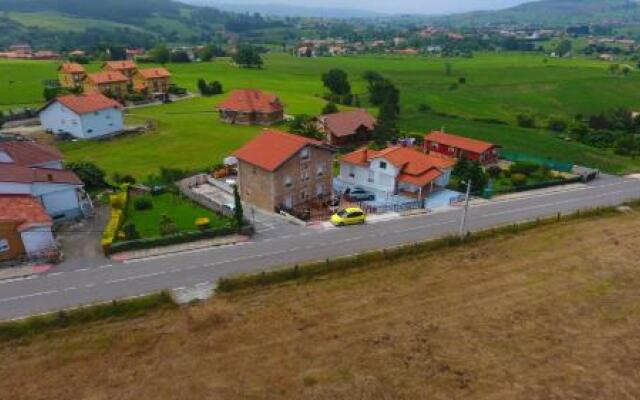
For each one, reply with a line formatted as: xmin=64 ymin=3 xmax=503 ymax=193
xmin=0 ymin=0 xmax=291 ymax=49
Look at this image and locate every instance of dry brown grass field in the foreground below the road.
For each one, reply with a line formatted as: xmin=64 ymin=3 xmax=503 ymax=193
xmin=0 ymin=213 xmax=640 ymax=400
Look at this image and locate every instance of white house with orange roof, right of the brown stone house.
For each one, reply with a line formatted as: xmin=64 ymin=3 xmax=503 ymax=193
xmin=338 ymin=146 xmax=455 ymax=200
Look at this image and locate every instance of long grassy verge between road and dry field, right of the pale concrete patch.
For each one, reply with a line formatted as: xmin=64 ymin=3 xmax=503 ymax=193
xmin=216 ymin=203 xmax=624 ymax=293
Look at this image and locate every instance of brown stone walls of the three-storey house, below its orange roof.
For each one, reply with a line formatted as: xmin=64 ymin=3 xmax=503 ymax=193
xmin=238 ymin=146 xmax=333 ymax=211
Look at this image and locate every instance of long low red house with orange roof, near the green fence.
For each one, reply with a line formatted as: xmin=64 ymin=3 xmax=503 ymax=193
xmin=424 ymin=131 xmax=500 ymax=165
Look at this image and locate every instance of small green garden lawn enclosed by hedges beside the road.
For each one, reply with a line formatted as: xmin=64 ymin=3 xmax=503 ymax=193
xmin=125 ymin=193 xmax=231 ymax=238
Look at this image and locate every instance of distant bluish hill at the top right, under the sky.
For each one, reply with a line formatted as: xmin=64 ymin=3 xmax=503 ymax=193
xmin=431 ymin=0 xmax=640 ymax=26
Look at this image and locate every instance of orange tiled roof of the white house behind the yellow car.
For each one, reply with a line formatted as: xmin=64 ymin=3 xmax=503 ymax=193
xmin=341 ymin=146 xmax=455 ymax=186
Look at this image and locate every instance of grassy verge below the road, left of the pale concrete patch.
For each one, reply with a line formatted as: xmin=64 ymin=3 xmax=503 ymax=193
xmin=0 ymin=291 xmax=177 ymax=340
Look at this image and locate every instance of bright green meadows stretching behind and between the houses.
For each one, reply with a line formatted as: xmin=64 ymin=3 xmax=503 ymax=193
xmin=0 ymin=53 xmax=640 ymax=177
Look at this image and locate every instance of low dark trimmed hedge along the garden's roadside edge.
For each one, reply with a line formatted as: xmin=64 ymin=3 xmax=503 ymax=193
xmin=105 ymin=226 xmax=253 ymax=255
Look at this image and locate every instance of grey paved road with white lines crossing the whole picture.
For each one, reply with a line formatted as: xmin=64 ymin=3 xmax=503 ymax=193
xmin=0 ymin=176 xmax=640 ymax=319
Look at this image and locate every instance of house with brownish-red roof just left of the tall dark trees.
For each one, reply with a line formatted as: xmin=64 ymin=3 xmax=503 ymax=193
xmin=317 ymin=108 xmax=376 ymax=146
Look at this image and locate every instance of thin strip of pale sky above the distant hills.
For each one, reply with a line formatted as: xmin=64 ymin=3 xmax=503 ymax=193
xmin=206 ymin=0 xmax=527 ymax=14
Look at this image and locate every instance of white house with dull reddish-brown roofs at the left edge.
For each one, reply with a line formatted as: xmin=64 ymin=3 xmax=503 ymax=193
xmin=0 ymin=142 xmax=93 ymax=221
